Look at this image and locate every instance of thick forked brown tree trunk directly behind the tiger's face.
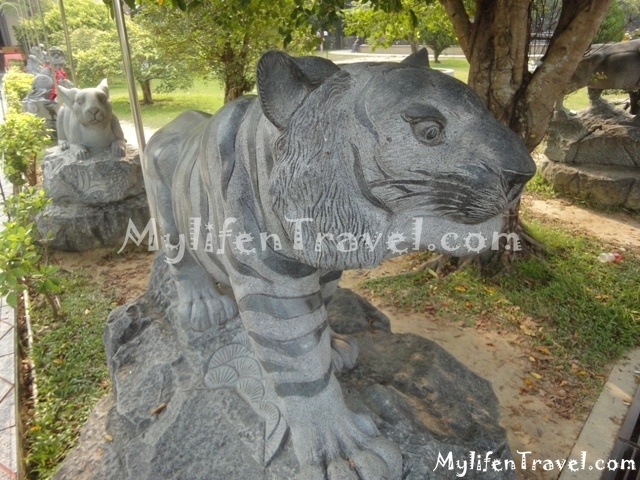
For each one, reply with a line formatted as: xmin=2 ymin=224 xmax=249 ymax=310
xmin=440 ymin=0 xmax=611 ymax=267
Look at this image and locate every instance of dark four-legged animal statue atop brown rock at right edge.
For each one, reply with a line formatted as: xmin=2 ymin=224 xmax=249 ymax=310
xmin=567 ymin=39 xmax=640 ymax=115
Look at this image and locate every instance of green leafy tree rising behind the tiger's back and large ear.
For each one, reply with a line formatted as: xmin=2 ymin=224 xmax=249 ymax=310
xmin=140 ymin=0 xmax=316 ymax=101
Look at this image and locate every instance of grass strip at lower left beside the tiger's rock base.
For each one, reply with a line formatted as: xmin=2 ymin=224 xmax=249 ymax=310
xmin=25 ymin=272 xmax=117 ymax=480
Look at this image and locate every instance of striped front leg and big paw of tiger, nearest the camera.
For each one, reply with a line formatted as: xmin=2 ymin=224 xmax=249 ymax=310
xmin=230 ymin=274 xmax=402 ymax=480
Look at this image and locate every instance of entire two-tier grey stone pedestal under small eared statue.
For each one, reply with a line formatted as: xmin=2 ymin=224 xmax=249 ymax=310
xmin=36 ymin=146 xmax=149 ymax=251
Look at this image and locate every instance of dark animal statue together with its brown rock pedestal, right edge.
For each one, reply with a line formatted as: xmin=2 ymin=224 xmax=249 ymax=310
xmin=540 ymin=40 xmax=640 ymax=210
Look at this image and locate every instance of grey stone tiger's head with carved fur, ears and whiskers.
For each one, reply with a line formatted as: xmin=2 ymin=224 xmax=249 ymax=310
xmin=257 ymin=50 xmax=535 ymax=269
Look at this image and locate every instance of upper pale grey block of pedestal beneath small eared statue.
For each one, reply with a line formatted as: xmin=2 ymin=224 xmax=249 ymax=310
xmin=42 ymin=147 xmax=145 ymax=206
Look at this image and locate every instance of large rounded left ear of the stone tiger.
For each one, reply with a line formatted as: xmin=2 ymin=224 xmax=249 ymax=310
xmin=256 ymin=50 xmax=340 ymax=130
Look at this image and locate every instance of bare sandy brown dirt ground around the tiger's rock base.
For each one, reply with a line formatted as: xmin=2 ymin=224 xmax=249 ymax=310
xmin=55 ymin=196 xmax=640 ymax=480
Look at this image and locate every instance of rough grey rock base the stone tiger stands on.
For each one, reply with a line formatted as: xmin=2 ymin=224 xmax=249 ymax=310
xmin=54 ymin=256 xmax=516 ymax=480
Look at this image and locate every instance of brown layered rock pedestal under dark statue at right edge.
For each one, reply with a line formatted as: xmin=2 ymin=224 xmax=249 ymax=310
xmin=539 ymin=100 xmax=640 ymax=210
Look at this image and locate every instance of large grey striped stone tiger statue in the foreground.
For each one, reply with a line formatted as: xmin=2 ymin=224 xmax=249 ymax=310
xmin=143 ymin=47 xmax=535 ymax=480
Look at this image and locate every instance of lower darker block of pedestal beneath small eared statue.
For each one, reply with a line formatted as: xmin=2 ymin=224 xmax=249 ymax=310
xmin=36 ymin=194 xmax=149 ymax=251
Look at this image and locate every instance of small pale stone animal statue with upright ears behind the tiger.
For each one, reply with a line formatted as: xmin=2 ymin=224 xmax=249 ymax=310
xmin=56 ymin=79 xmax=125 ymax=159
